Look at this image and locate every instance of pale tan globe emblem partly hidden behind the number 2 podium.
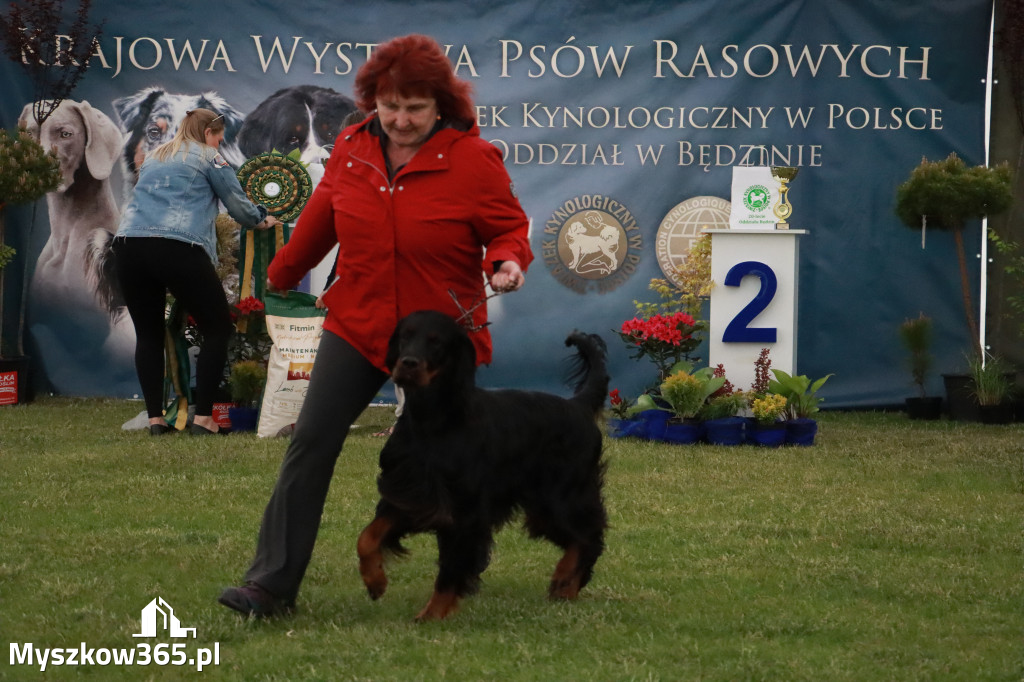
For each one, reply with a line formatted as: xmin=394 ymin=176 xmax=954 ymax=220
xmin=654 ymin=197 xmax=732 ymax=289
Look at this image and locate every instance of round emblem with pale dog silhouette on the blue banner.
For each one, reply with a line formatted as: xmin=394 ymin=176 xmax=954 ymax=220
xmin=542 ymin=195 xmax=643 ymax=294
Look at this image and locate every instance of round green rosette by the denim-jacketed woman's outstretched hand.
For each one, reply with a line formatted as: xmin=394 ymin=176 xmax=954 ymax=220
xmin=238 ymin=152 xmax=313 ymax=222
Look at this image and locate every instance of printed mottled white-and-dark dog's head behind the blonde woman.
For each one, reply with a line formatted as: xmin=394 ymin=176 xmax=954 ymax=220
xmin=114 ymin=87 xmax=245 ymax=186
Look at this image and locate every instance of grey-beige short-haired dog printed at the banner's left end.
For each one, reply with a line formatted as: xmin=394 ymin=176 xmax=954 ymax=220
xmin=18 ymin=100 xmax=135 ymax=394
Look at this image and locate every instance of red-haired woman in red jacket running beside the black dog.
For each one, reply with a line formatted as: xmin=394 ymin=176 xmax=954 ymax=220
xmin=219 ymin=35 xmax=532 ymax=616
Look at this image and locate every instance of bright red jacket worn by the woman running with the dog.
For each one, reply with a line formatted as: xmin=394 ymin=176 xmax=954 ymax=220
xmin=267 ymin=119 xmax=534 ymax=371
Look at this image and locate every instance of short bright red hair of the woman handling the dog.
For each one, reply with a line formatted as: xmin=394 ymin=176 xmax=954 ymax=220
xmin=355 ymin=34 xmax=476 ymax=126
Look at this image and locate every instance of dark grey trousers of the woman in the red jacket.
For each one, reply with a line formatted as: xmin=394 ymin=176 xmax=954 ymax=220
xmin=245 ymin=331 xmax=388 ymax=601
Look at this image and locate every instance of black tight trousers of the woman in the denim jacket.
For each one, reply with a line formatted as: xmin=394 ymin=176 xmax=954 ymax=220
xmin=113 ymin=237 xmax=233 ymax=419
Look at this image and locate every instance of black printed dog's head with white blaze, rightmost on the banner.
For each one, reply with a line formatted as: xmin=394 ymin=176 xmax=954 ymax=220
xmin=239 ymin=85 xmax=355 ymax=164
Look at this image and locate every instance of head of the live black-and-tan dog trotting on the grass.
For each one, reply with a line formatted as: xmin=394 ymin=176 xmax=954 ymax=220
xmin=386 ymin=310 xmax=476 ymax=390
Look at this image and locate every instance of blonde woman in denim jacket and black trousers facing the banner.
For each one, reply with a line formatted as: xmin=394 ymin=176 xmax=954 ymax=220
xmin=114 ymin=109 xmax=280 ymax=435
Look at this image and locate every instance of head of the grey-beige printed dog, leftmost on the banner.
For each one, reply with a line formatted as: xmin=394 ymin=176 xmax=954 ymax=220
xmin=17 ymin=99 xmax=122 ymax=191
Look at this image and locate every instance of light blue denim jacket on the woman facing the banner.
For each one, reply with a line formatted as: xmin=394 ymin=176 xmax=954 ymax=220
xmin=118 ymin=141 xmax=267 ymax=263
